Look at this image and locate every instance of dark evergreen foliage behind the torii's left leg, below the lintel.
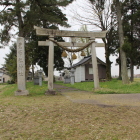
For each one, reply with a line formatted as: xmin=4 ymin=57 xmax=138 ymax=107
xmin=30 ymin=34 xmax=64 ymax=76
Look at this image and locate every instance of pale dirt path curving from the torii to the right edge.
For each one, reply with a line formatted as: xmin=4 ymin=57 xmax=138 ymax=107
xmin=54 ymin=84 xmax=140 ymax=107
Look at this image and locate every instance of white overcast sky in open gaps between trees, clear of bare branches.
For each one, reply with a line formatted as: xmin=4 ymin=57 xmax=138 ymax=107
xmin=0 ymin=0 xmax=140 ymax=76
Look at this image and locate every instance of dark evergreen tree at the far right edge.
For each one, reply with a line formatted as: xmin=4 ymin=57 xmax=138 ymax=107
xmin=122 ymin=0 xmax=140 ymax=82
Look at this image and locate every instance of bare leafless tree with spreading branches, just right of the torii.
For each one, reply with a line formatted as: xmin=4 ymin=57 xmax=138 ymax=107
xmin=69 ymin=0 xmax=117 ymax=80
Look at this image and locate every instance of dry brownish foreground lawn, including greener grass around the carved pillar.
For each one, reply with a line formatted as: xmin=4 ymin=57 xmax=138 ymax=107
xmin=0 ymin=81 xmax=140 ymax=140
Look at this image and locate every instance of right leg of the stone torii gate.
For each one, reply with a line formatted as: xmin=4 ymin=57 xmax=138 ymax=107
xmin=91 ymin=38 xmax=100 ymax=89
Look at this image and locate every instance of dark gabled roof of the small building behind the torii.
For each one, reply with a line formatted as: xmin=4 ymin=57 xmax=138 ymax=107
xmin=71 ymin=55 xmax=106 ymax=68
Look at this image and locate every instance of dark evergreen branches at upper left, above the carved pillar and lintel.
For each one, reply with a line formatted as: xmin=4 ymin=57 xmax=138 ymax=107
xmin=0 ymin=0 xmax=73 ymax=43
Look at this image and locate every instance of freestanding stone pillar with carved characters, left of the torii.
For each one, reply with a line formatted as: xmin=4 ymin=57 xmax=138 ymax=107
xmin=15 ymin=37 xmax=29 ymax=95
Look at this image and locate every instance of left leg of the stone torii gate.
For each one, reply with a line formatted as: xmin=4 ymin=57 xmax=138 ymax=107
xmin=46 ymin=36 xmax=55 ymax=94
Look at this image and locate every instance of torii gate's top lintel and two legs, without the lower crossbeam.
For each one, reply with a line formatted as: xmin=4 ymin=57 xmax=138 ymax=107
xmin=34 ymin=26 xmax=107 ymax=94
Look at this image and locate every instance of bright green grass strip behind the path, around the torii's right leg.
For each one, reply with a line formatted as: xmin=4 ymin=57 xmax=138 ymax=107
xmin=57 ymin=79 xmax=140 ymax=94
